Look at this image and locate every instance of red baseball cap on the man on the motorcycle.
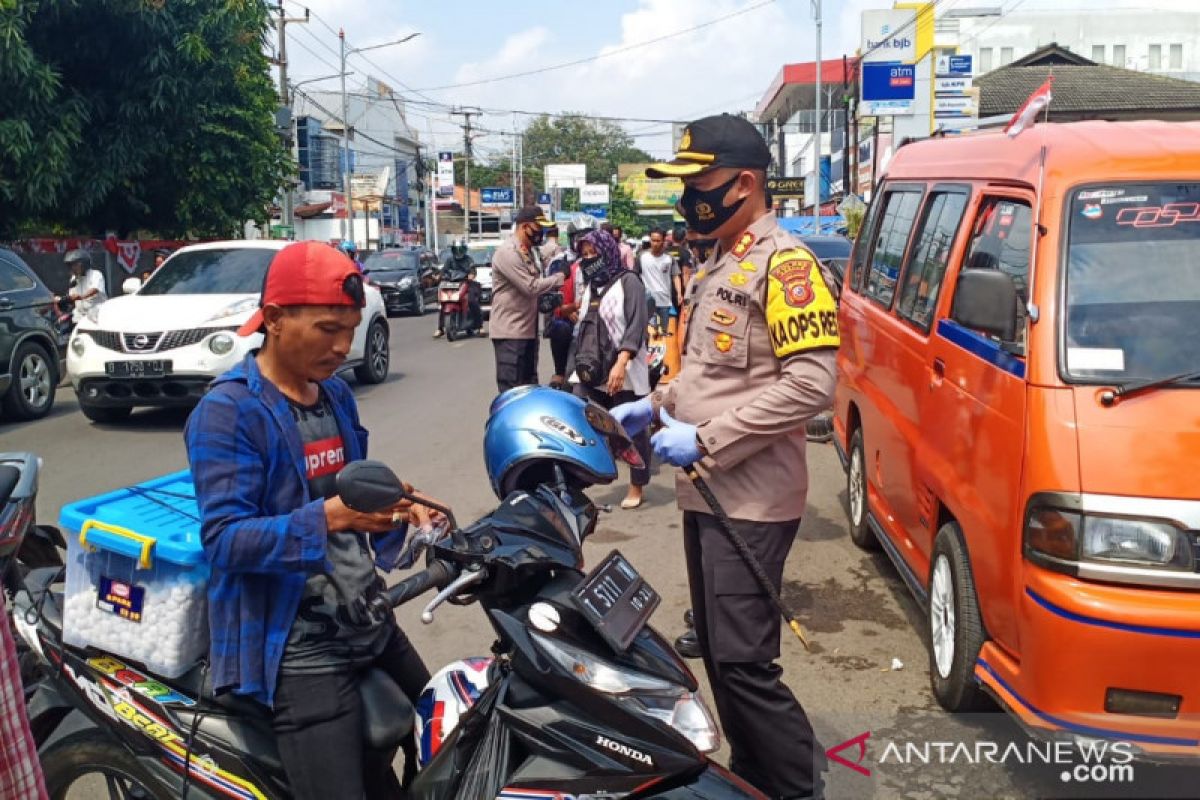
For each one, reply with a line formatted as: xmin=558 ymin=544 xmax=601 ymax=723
xmin=238 ymin=241 xmax=364 ymax=336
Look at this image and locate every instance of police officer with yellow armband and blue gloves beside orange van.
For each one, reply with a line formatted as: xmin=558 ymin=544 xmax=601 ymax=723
xmin=613 ymin=114 xmax=840 ymax=798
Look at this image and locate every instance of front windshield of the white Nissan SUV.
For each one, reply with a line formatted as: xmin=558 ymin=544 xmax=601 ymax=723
xmin=138 ymin=247 xmax=278 ymax=295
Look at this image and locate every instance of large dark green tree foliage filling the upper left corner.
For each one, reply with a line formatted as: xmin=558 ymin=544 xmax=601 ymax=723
xmin=0 ymin=0 xmax=290 ymax=235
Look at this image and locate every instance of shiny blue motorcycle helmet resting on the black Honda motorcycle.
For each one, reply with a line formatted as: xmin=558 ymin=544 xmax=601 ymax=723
xmin=484 ymin=386 xmax=641 ymax=500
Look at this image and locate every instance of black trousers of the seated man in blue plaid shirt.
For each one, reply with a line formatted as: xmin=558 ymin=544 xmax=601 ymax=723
xmin=272 ymin=627 xmax=430 ymax=800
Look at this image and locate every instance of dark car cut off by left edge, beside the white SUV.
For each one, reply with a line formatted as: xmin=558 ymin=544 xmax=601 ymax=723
xmin=0 ymin=248 xmax=62 ymax=420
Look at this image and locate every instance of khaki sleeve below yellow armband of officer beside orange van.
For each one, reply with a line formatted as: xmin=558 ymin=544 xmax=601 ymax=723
xmin=696 ymin=348 xmax=838 ymax=470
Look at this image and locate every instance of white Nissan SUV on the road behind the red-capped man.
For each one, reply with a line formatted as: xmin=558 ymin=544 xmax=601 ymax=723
xmin=67 ymin=241 xmax=390 ymax=422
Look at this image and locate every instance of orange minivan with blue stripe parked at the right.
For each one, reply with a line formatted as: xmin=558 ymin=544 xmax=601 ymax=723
xmin=834 ymin=121 xmax=1200 ymax=758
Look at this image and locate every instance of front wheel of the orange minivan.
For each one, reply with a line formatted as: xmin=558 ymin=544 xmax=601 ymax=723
xmin=929 ymin=522 xmax=989 ymax=711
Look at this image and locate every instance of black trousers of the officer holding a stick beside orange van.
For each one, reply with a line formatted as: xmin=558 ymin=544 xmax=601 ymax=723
xmin=683 ymin=511 xmax=824 ymax=798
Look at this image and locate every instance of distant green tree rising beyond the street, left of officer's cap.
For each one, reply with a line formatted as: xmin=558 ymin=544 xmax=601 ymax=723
xmin=524 ymin=114 xmax=653 ymax=191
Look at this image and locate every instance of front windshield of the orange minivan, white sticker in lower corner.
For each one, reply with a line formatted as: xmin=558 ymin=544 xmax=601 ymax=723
xmin=1063 ymin=182 xmax=1200 ymax=383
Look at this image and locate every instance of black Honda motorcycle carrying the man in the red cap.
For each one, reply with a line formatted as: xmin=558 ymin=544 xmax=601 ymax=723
xmin=12 ymin=438 xmax=763 ymax=800
